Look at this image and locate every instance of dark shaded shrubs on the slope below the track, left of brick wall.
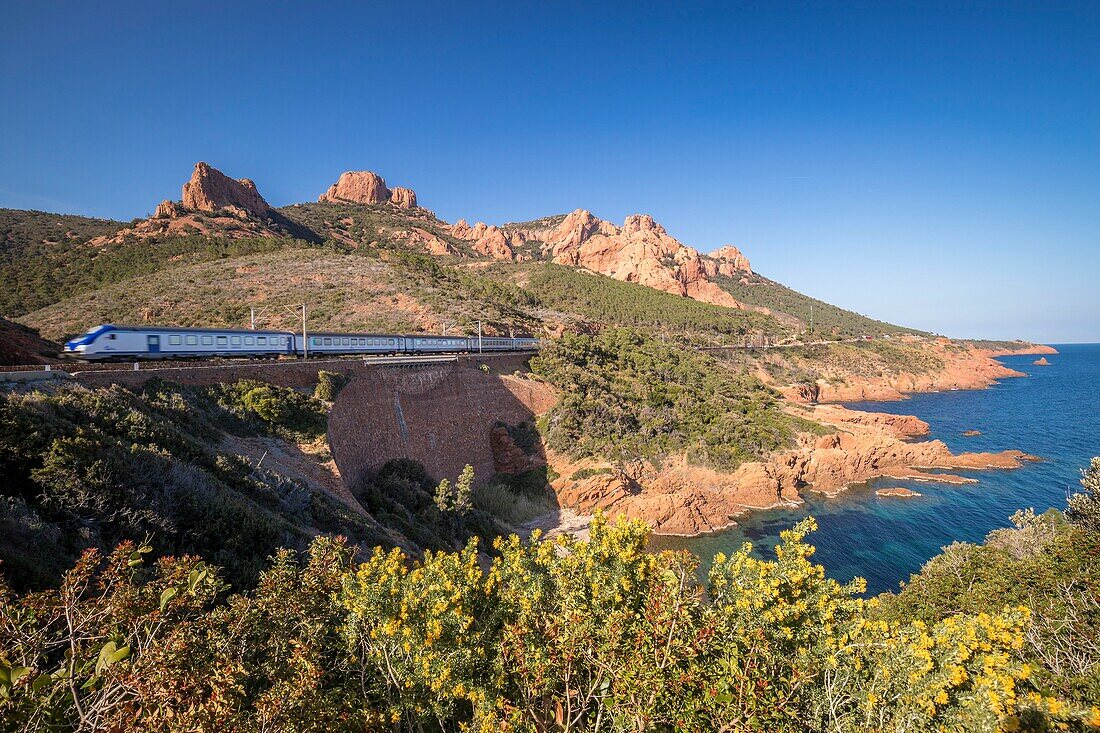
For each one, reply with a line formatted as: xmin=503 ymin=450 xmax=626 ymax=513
xmin=0 ymin=382 xmax=384 ymax=586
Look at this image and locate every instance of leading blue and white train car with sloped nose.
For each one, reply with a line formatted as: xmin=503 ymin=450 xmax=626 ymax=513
xmin=63 ymin=324 xmax=295 ymax=361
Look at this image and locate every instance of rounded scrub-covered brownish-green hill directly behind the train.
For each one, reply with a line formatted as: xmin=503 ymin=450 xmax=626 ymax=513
xmin=21 ymin=241 xmax=540 ymax=338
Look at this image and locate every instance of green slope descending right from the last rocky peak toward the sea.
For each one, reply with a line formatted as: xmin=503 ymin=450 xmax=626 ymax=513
xmin=717 ymin=269 xmax=927 ymax=338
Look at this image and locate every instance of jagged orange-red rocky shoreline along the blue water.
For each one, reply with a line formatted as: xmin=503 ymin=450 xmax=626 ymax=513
xmin=541 ymin=342 xmax=1056 ymax=537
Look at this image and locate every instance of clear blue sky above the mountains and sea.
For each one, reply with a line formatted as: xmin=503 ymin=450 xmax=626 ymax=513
xmin=0 ymin=0 xmax=1100 ymax=341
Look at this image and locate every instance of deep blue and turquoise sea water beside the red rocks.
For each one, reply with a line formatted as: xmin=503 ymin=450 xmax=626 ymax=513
xmin=655 ymin=344 xmax=1100 ymax=593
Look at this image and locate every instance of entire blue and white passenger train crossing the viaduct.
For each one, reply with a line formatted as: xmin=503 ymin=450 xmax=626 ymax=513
xmin=63 ymin=324 xmax=539 ymax=361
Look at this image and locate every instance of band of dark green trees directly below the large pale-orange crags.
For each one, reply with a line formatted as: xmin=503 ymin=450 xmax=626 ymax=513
xmin=526 ymin=263 xmax=783 ymax=341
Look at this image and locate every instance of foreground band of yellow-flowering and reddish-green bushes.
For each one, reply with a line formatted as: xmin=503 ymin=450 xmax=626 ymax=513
xmin=0 ymin=508 xmax=1100 ymax=733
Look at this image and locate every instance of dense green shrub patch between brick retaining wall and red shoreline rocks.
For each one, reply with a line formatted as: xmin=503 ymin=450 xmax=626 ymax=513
xmin=531 ymin=329 xmax=822 ymax=470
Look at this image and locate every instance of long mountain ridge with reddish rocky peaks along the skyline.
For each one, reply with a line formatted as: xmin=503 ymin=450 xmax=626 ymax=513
xmin=0 ymin=162 xmax=920 ymax=338
